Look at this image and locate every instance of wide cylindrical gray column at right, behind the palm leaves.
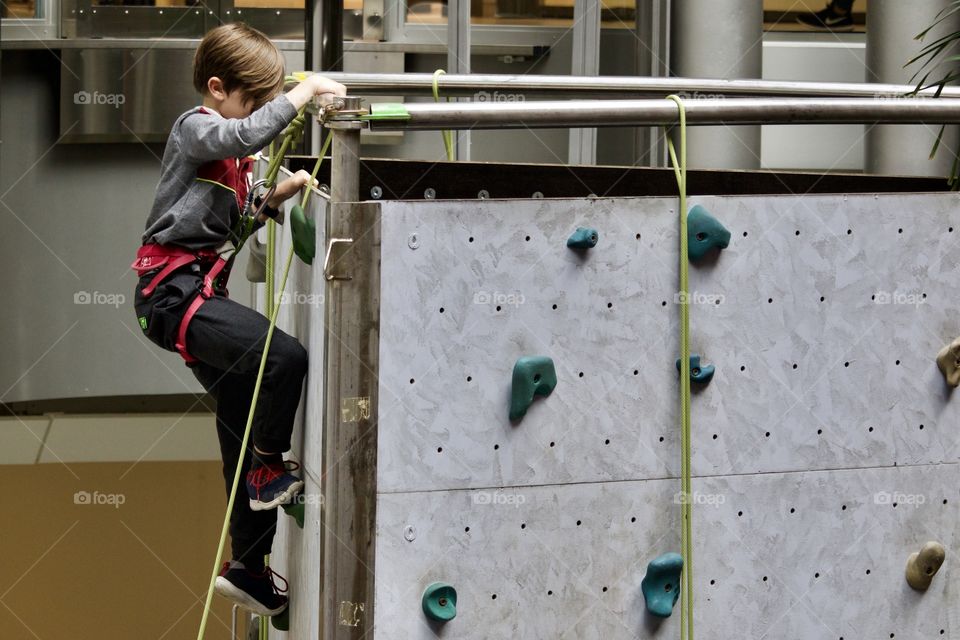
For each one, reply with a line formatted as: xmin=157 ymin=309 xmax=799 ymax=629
xmin=864 ymin=0 xmax=960 ymax=175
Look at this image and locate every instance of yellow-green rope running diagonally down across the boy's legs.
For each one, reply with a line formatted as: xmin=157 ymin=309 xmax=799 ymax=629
xmin=197 ymin=96 xmax=323 ymax=640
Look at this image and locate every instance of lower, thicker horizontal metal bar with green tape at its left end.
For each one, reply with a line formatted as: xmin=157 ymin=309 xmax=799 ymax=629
xmin=369 ymin=98 xmax=960 ymax=131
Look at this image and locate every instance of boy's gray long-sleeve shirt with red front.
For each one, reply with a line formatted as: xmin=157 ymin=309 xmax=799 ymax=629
xmin=142 ymin=95 xmax=297 ymax=249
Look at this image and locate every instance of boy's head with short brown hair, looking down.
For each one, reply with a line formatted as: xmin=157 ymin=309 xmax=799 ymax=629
xmin=193 ymin=22 xmax=284 ymax=118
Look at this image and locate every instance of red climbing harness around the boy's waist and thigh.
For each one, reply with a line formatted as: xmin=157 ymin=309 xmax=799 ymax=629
xmin=131 ymin=244 xmax=233 ymax=364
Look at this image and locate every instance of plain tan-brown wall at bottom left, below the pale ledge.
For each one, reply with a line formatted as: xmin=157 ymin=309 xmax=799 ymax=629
xmin=0 ymin=461 xmax=244 ymax=640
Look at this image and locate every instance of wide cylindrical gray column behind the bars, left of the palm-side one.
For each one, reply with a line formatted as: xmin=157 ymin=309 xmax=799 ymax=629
xmin=670 ymin=0 xmax=763 ymax=169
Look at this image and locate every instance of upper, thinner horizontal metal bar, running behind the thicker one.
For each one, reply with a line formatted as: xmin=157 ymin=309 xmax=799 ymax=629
xmin=326 ymin=73 xmax=960 ymax=99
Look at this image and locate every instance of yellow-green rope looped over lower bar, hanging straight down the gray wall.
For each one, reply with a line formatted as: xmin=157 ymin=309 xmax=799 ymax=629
xmin=667 ymin=95 xmax=693 ymax=640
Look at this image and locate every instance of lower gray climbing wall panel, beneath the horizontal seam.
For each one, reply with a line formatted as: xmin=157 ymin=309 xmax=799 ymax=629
xmin=375 ymin=465 xmax=960 ymax=640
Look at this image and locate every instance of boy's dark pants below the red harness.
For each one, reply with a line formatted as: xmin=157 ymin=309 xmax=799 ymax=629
xmin=134 ymin=270 xmax=307 ymax=567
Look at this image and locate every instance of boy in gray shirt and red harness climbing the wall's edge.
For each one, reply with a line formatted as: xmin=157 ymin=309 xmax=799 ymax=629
xmin=133 ymin=23 xmax=346 ymax=615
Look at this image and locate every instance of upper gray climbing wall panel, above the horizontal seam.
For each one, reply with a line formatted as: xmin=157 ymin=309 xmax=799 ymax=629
xmin=378 ymin=194 xmax=960 ymax=491
